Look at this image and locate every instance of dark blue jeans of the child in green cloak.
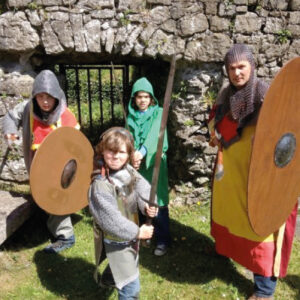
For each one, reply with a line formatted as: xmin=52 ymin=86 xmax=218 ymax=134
xmin=154 ymin=206 xmax=171 ymax=246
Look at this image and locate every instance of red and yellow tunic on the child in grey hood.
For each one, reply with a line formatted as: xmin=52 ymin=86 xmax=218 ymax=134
xmin=30 ymin=108 xmax=80 ymax=151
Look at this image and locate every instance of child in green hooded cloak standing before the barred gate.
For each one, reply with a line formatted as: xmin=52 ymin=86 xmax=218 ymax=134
xmin=127 ymin=77 xmax=171 ymax=256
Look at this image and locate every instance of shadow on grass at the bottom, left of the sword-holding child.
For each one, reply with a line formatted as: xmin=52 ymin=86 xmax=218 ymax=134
xmin=33 ymin=251 xmax=113 ymax=300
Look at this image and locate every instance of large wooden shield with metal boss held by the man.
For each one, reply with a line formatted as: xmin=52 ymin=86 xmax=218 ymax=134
xmin=248 ymin=57 xmax=300 ymax=236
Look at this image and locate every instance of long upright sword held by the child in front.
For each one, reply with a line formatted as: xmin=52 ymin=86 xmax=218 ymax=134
xmin=146 ymin=54 xmax=176 ymax=225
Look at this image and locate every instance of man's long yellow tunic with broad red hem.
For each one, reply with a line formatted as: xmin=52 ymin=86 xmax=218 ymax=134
xmin=211 ymin=110 xmax=297 ymax=277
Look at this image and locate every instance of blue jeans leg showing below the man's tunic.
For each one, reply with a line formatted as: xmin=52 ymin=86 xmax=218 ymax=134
xmin=254 ymin=273 xmax=277 ymax=298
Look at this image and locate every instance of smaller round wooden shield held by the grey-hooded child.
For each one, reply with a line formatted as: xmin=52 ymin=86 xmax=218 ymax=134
xmin=30 ymin=127 xmax=94 ymax=215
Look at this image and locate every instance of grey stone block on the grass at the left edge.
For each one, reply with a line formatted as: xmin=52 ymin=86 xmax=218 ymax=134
xmin=0 ymin=191 xmax=35 ymax=245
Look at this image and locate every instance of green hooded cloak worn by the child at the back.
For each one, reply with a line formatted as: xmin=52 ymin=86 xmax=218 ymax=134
xmin=127 ymin=77 xmax=169 ymax=206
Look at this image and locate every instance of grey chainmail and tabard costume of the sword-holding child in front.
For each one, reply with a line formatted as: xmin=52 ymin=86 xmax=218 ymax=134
xmin=89 ymin=165 xmax=155 ymax=289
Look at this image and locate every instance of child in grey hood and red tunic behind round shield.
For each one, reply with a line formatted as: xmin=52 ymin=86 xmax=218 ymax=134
xmin=3 ymin=70 xmax=79 ymax=253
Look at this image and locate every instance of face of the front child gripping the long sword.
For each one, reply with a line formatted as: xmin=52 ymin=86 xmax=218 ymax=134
xmin=103 ymin=143 xmax=129 ymax=171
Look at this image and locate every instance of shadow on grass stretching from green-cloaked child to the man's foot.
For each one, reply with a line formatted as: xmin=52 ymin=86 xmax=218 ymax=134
xmin=140 ymin=219 xmax=253 ymax=296
